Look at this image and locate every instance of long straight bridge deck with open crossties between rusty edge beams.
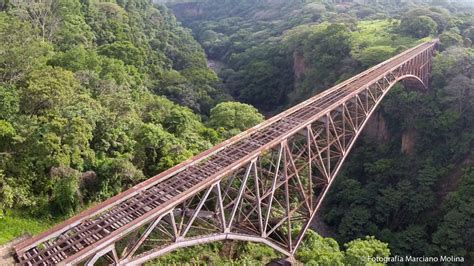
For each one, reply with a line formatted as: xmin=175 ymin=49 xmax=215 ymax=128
xmin=15 ymin=42 xmax=434 ymax=265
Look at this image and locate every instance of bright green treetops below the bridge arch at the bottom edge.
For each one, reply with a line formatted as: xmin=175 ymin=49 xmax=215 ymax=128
xmin=150 ymin=230 xmax=390 ymax=265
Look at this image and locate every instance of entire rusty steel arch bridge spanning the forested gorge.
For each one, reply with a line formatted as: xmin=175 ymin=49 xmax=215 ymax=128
xmin=15 ymin=40 xmax=437 ymax=265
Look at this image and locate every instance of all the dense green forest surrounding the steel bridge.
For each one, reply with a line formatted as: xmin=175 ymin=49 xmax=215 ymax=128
xmin=0 ymin=0 xmax=474 ymax=265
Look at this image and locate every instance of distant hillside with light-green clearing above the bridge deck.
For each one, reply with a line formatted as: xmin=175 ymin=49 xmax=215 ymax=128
xmin=169 ymin=0 xmax=436 ymax=113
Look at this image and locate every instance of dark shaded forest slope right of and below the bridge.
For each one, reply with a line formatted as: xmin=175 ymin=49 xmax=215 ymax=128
xmin=326 ymin=44 xmax=474 ymax=260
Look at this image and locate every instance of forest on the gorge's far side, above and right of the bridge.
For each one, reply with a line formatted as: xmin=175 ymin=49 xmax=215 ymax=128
xmin=160 ymin=0 xmax=474 ymax=262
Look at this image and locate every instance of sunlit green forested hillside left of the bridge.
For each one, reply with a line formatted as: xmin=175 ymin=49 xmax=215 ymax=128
xmin=0 ymin=0 xmax=234 ymax=220
